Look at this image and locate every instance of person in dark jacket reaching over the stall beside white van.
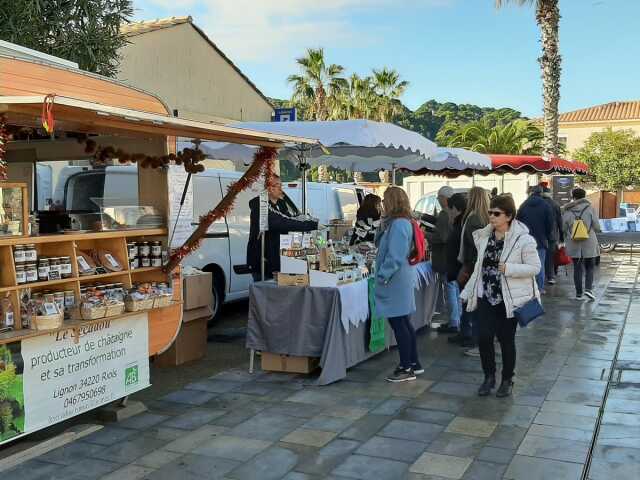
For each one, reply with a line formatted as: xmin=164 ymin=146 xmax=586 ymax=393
xmin=247 ymin=176 xmax=318 ymax=281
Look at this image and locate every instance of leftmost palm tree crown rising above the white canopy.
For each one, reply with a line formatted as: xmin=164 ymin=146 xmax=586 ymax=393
xmin=287 ymin=48 xmax=346 ymax=120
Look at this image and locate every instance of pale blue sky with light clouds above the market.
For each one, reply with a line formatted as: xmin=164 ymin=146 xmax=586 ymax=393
xmin=134 ymin=0 xmax=640 ymax=116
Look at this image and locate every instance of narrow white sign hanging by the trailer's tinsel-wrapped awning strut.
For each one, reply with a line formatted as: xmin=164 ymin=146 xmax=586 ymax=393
xmin=167 ymin=165 xmax=196 ymax=248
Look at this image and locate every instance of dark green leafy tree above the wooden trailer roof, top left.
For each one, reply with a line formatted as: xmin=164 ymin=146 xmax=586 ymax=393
xmin=0 ymin=0 xmax=133 ymax=77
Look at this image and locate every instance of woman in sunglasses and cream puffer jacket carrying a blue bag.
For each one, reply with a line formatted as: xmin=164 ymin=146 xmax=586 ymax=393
xmin=461 ymin=195 xmax=540 ymax=397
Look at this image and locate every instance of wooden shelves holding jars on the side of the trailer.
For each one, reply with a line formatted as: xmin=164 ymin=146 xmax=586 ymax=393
xmin=0 ymin=228 xmax=171 ymax=334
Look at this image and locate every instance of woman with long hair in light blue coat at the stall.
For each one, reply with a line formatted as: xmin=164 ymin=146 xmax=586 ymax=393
xmin=375 ymin=187 xmax=424 ymax=382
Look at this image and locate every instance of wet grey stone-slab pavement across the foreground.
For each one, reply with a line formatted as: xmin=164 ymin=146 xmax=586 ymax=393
xmin=3 ymin=256 xmax=640 ymax=480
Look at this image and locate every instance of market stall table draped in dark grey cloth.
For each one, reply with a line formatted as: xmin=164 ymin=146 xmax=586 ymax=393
xmin=247 ymin=263 xmax=440 ymax=385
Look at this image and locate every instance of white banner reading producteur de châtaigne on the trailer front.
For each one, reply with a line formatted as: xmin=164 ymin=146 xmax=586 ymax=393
xmin=0 ymin=313 xmax=149 ymax=444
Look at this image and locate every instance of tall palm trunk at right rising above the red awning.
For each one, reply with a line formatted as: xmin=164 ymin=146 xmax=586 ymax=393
xmin=495 ymin=0 xmax=561 ymax=157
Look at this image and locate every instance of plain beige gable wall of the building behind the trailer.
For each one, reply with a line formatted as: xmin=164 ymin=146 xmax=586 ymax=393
xmin=118 ymin=23 xmax=273 ymax=122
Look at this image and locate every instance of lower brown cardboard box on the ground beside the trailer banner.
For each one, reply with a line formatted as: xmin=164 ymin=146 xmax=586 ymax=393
xmin=155 ymin=307 xmax=212 ymax=367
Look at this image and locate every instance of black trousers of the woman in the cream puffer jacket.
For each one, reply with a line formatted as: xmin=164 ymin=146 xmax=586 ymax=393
xmin=474 ymin=298 xmax=518 ymax=381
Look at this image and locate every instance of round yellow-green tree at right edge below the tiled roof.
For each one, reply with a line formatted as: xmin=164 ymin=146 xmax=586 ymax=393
xmin=573 ymin=128 xmax=640 ymax=192
